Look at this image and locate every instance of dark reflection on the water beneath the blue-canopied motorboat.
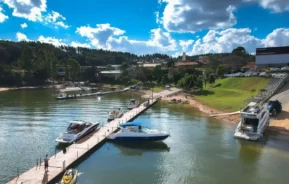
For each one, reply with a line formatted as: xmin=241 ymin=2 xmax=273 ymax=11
xmin=112 ymin=142 xmax=170 ymax=156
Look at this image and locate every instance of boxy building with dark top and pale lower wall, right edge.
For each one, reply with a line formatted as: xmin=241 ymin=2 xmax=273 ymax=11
xmin=256 ymin=46 xmax=289 ymax=67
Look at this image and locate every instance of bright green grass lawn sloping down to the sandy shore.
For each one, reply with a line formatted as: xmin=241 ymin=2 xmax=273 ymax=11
xmin=195 ymin=77 xmax=271 ymax=112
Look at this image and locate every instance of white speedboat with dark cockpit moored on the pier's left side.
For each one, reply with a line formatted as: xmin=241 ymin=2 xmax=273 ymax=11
xmin=56 ymin=120 xmax=99 ymax=144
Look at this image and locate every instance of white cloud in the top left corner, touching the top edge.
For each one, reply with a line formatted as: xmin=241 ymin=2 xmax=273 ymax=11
xmin=2 ymin=0 xmax=47 ymax=21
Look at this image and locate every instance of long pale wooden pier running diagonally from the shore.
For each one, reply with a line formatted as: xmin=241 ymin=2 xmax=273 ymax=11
xmin=8 ymin=99 xmax=158 ymax=184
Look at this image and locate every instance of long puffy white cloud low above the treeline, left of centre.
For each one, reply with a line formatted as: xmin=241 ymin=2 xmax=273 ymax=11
xmin=76 ymin=24 xmax=177 ymax=54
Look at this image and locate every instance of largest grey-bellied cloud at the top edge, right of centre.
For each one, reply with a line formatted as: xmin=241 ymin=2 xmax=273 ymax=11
xmin=162 ymin=0 xmax=241 ymax=32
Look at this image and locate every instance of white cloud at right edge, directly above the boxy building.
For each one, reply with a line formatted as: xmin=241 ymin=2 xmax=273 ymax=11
xmin=264 ymin=28 xmax=289 ymax=47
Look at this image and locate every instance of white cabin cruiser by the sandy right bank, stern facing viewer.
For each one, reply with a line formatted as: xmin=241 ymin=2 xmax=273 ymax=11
xmin=234 ymin=104 xmax=270 ymax=141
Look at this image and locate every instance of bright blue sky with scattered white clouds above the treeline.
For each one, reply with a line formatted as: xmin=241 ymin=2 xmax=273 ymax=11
xmin=0 ymin=0 xmax=289 ymax=56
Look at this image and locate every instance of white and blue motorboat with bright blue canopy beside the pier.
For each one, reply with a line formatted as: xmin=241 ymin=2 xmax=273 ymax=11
xmin=108 ymin=123 xmax=170 ymax=142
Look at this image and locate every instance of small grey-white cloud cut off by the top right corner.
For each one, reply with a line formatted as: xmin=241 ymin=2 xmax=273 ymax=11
xmin=244 ymin=0 xmax=289 ymax=13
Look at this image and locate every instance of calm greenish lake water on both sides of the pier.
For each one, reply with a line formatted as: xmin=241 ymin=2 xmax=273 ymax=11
xmin=0 ymin=90 xmax=289 ymax=184
